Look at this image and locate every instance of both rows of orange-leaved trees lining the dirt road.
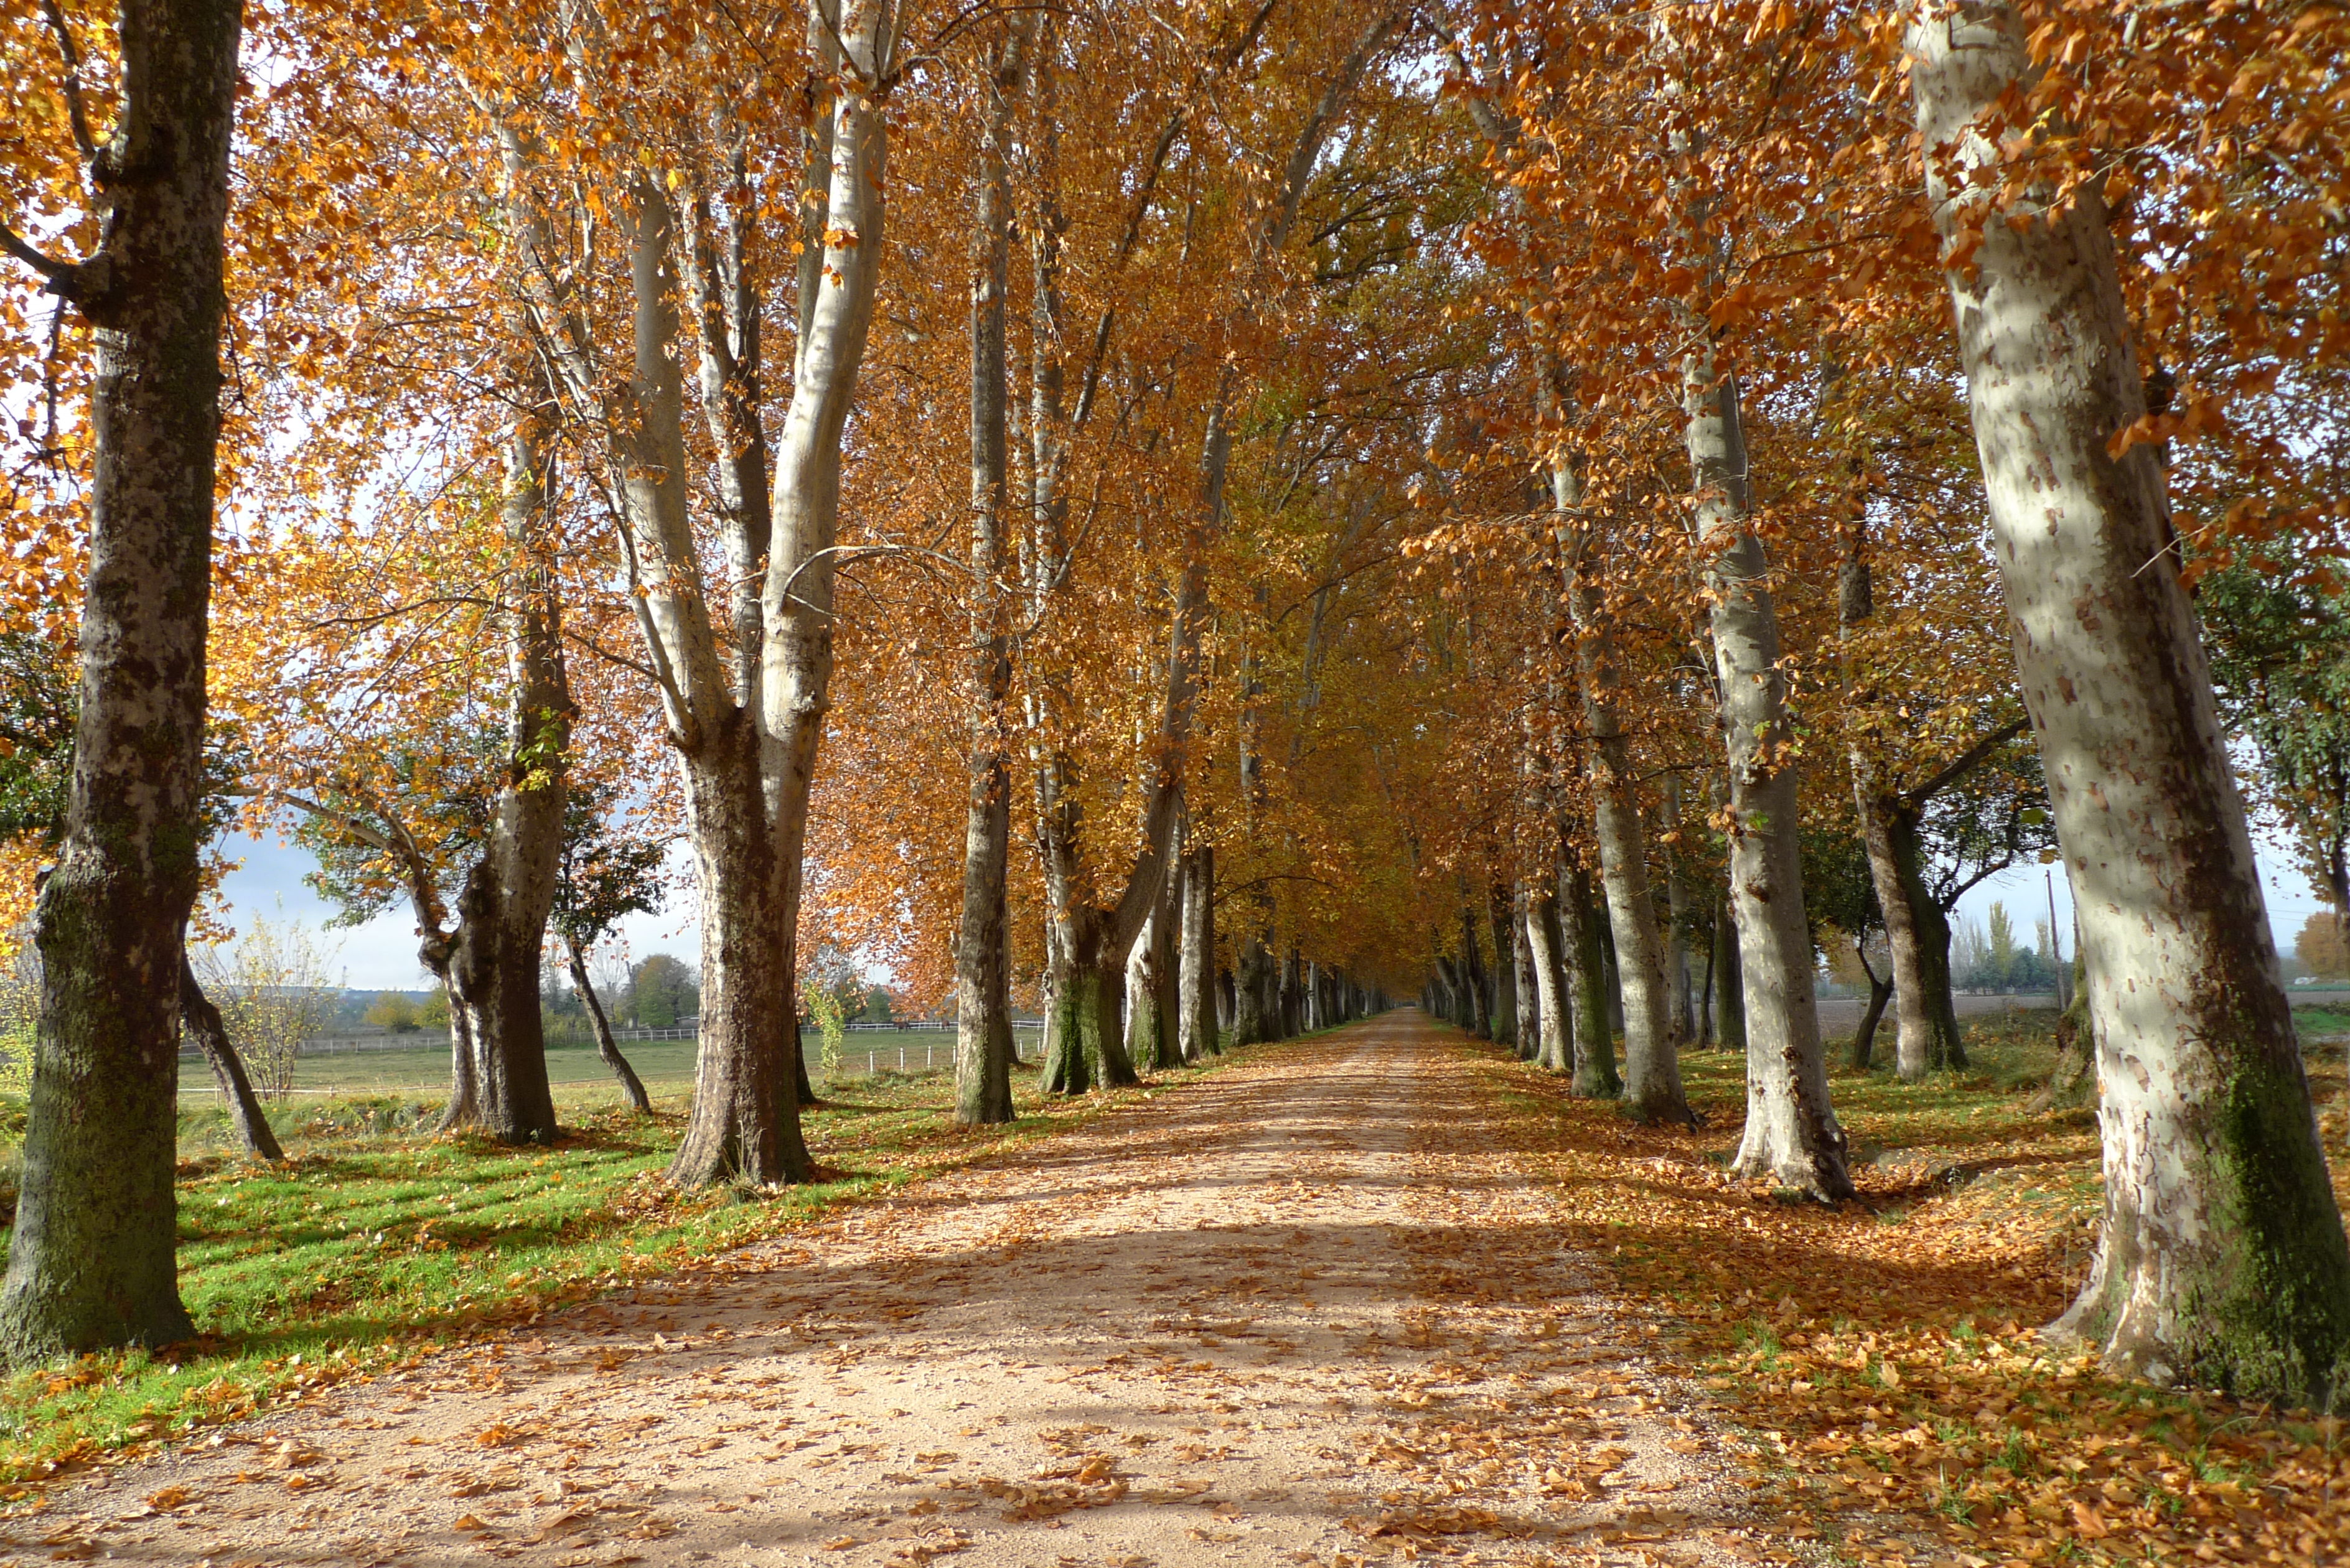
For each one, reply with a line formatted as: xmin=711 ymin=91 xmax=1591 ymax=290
xmin=0 ymin=0 xmax=2350 ymax=1394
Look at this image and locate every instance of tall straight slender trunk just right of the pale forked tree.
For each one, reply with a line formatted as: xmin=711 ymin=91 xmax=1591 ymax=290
xmin=954 ymin=21 xmax=1024 ymax=1126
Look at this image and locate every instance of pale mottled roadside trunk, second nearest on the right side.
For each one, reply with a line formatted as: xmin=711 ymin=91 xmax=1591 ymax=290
xmin=1680 ymin=338 xmax=1854 ymax=1203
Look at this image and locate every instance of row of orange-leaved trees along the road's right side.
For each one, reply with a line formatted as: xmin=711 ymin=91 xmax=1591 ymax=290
xmin=1391 ymin=5 xmax=2350 ymax=1399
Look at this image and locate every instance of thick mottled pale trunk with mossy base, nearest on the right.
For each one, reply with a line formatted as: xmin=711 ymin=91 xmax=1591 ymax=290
xmin=1908 ymin=5 xmax=2350 ymax=1408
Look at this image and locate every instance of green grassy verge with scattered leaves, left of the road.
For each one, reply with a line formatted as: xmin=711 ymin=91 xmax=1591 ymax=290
xmin=0 ymin=1034 xmax=1248 ymax=1498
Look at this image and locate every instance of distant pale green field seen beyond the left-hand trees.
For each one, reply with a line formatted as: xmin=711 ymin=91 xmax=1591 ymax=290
xmin=179 ymin=1030 xmax=1039 ymax=1109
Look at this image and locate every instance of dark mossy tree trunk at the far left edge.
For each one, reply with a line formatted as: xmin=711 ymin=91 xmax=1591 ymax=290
xmin=0 ymin=0 xmax=242 ymax=1363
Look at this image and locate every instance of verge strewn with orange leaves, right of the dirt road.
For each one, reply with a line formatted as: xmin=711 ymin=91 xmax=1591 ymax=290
xmin=1478 ymin=1013 xmax=2350 ymax=1568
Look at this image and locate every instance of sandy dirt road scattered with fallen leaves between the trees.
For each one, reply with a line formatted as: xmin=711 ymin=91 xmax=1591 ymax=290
xmin=0 ymin=1013 xmax=1753 ymax=1568
